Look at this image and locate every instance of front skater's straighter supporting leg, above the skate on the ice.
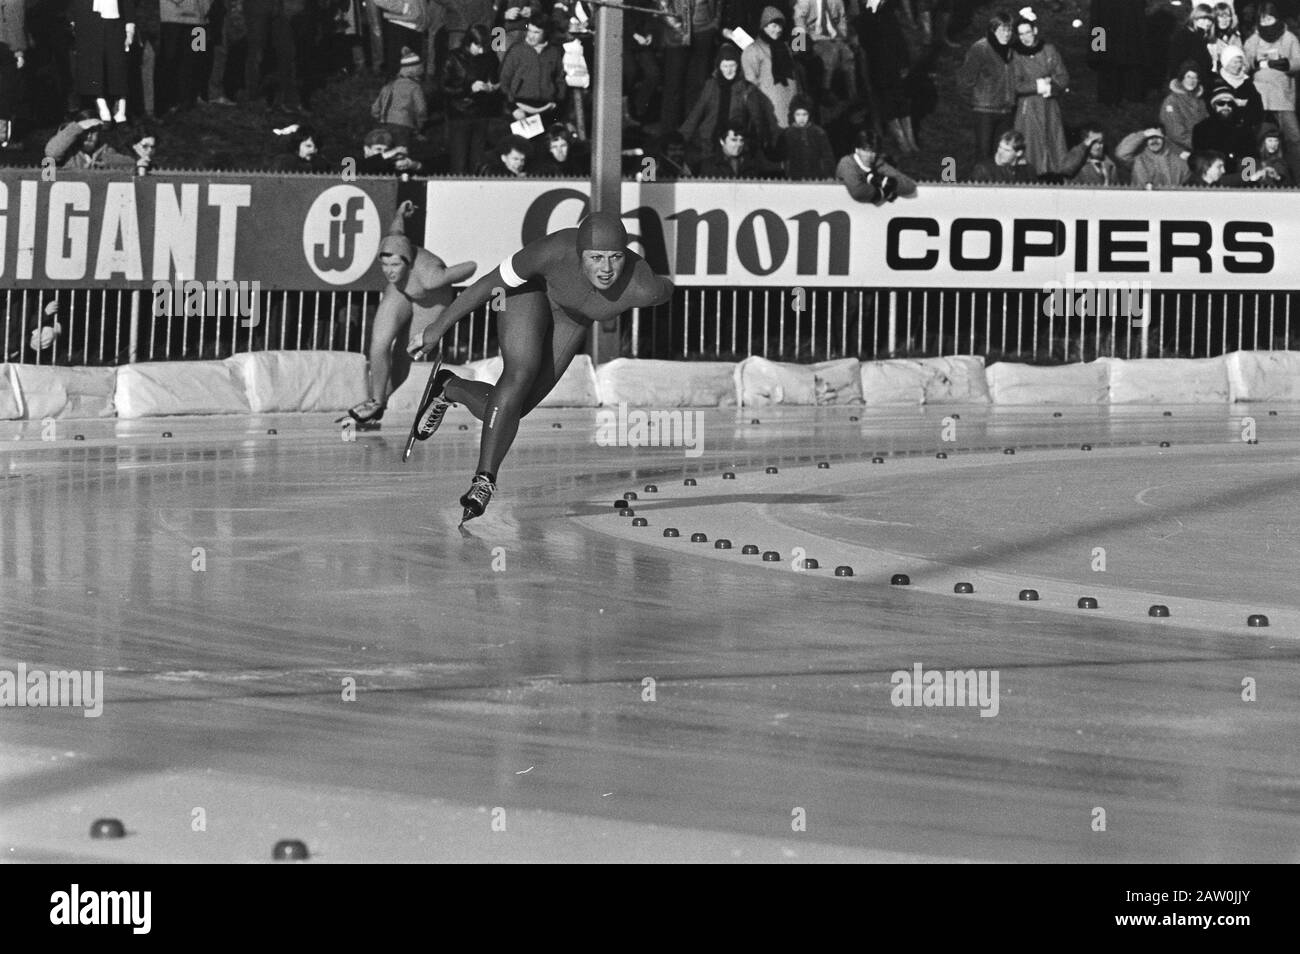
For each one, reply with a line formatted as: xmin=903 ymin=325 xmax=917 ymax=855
xmin=478 ymin=291 xmax=551 ymax=478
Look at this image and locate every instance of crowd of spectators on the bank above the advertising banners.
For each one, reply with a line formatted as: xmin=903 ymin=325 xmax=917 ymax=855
xmin=0 ymin=0 xmax=1300 ymax=187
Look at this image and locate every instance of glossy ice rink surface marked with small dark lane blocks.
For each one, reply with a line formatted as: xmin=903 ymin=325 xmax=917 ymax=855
xmin=0 ymin=406 xmax=1300 ymax=862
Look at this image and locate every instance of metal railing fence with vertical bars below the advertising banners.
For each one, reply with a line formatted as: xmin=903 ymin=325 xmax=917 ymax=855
xmin=0 ymin=287 xmax=1300 ymax=365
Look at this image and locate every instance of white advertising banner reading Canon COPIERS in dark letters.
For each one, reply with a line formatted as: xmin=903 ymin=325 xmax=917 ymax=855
xmin=425 ymin=179 xmax=1284 ymax=291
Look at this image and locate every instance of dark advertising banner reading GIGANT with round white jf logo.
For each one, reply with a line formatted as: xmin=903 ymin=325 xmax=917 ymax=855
xmin=0 ymin=169 xmax=397 ymax=291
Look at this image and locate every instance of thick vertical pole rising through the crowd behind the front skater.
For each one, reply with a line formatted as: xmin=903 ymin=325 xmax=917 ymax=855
xmin=592 ymin=6 xmax=623 ymax=364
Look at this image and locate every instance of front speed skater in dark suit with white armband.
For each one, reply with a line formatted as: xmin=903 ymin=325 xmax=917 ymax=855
xmin=415 ymin=212 xmax=673 ymax=520
